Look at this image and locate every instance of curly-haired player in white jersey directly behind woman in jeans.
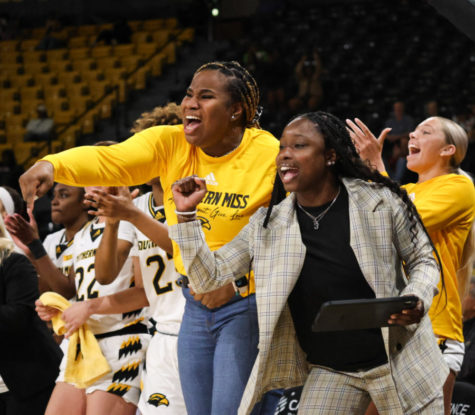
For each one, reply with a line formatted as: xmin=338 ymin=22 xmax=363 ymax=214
xmin=86 ymin=104 xmax=186 ymax=415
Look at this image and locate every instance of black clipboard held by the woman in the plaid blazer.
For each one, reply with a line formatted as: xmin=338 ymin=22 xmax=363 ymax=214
xmin=312 ymin=296 xmax=419 ymax=332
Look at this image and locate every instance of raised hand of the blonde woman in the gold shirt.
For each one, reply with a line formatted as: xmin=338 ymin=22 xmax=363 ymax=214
xmin=346 ymin=118 xmax=391 ymax=172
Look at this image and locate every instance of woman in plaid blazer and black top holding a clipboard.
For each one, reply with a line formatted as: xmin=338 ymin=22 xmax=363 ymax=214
xmin=170 ymin=112 xmax=448 ymax=415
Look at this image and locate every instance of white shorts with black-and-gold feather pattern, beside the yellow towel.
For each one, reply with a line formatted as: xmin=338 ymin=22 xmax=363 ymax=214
xmin=56 ymin=333 xmax=151 ymax=405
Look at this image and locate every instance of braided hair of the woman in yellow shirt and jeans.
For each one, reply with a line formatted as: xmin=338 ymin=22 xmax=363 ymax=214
xmin=195 ymin=61 xmax=262 ymax=128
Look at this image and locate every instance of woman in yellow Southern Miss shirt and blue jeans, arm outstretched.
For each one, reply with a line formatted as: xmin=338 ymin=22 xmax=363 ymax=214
xmin=20 ymin=62 xmax=278 ymax=415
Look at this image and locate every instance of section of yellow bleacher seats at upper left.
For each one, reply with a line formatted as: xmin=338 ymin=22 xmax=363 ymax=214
xmin=0 ymin=18 xmax=194 ymax=167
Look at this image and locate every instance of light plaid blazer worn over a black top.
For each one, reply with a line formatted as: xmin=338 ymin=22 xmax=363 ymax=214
xmin=170 ymin=179 xmax=448 ymax=414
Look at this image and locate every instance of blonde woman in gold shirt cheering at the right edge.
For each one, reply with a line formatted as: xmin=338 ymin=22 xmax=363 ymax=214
xmin=347 ymin=117 xmax=475 ymax=415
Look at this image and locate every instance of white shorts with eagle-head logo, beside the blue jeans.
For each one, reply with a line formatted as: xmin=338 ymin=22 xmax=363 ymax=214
xmin=139 ymin=332 xmax=186 ymax=415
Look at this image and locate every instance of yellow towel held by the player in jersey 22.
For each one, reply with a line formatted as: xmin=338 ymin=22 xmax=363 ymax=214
xmin=40 ymin=292 xmax=111 ymax=389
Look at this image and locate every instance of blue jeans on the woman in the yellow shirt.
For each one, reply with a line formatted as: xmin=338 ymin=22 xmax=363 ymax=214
xmin=178 ymin=288 xmax=259 ymax=415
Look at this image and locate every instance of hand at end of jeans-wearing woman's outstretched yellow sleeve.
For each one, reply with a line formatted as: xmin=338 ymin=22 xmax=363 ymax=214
xmin=19 ymin=161 xmax=54 ymax=210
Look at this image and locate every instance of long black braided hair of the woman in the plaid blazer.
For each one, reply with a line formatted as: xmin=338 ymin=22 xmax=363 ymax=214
xmin=263 ymin=111 xmax=445 ymax=302
